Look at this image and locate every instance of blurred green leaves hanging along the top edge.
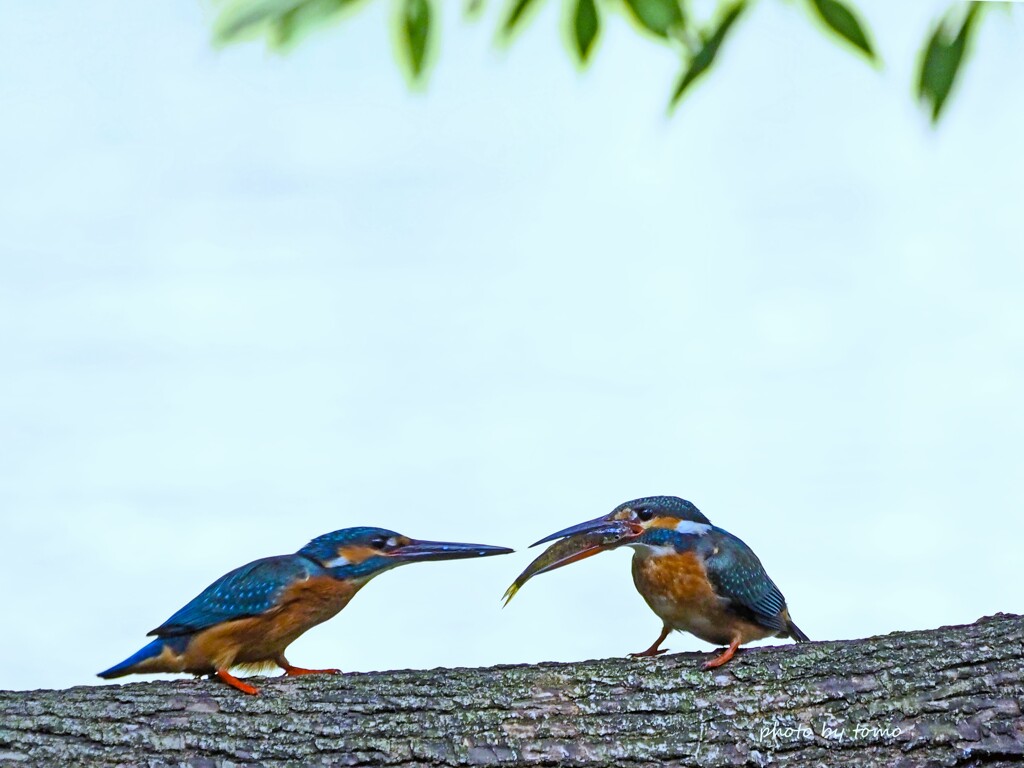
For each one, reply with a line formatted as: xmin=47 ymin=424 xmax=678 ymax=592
xmin=214 ymin=0 xmax=1010 ymax=122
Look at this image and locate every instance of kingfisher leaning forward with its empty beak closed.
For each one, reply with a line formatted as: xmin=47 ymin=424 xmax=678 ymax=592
xmin=99 ymin=527 xmax=513 ymax=695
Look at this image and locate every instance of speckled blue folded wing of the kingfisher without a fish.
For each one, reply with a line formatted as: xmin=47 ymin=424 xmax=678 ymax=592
xmin=150 ymin=555 xmax=323 ymax=637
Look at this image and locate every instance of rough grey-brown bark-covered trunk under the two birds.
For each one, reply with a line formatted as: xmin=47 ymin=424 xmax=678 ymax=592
xmin=0 ymin=614 xmax=1024 ymax=767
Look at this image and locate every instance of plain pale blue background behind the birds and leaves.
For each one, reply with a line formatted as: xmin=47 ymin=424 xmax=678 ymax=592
xmin=0 ymin=0 xmax=1024 ymax=688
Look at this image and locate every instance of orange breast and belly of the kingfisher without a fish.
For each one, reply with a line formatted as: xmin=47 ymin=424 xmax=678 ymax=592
xmin=184 ymin=577 xmax=362 ymax=671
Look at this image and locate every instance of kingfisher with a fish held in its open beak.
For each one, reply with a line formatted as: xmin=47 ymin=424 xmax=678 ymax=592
xmin=531 ymin=496 xmax=809 ymax=669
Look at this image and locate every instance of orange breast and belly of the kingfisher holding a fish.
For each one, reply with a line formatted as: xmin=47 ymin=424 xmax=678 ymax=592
xmin=633 ymin=552 xmax=768 ymax=645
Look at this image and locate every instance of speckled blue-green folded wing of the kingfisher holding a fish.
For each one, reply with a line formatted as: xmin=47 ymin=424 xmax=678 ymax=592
xmin=701 ymin=528 xmax=788 ymax=632
